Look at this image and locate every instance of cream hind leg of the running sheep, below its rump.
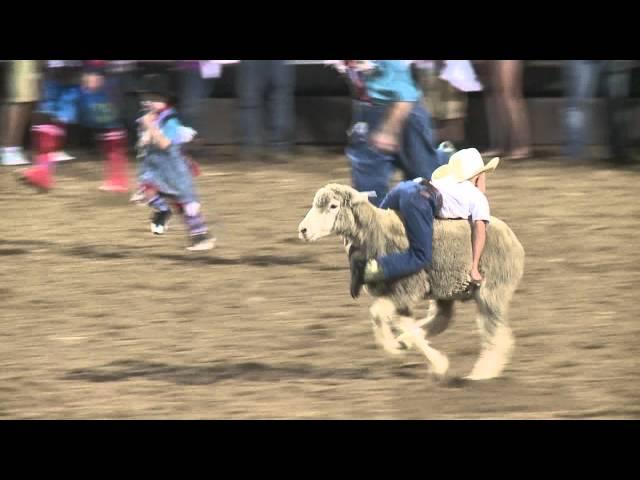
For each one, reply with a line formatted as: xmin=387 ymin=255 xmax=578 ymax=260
xmin=466 ymin=291 xmax=515 ymax=380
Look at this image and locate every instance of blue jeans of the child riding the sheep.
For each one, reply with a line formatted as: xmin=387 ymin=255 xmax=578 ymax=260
xmin=377 ymin=181 xmax=437 ymax=280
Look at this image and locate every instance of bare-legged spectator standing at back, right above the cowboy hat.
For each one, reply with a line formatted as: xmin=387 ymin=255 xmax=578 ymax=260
xmin=482 ymin=60 xmax=531 ymax=160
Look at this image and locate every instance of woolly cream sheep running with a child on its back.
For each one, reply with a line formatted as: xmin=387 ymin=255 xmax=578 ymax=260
xmin=298 ymin=183 xmax=525 ymax=380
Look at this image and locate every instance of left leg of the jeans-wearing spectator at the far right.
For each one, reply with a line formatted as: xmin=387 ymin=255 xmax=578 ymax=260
xmin=566 ymin=60 xmax=602 ymax=158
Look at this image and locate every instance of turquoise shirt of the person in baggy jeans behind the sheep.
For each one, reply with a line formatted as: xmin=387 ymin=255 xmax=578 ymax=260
xmin=364 ymin=60 xmax=422 ymax=102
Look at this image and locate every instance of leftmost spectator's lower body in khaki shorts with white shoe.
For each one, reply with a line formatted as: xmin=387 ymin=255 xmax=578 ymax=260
xmin=0 ymin=60 xmax=41 ymax=165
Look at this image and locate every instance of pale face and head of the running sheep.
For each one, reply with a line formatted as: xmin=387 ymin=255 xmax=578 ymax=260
xmin=298 ymin=183 xmax=368 ymax=242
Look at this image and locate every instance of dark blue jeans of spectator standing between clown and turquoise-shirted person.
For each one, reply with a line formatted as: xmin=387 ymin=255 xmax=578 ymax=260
xmin=237 ymin=60 xmax=295 ymax=150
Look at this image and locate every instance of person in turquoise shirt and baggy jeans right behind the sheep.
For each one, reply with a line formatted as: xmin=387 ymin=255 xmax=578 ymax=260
xmin=337 ymin=60 xmax=453 ymax=205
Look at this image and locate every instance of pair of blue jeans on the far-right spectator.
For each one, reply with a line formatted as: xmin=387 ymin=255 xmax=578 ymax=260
xmin=566 ymin=60 xmax=631 ymax=158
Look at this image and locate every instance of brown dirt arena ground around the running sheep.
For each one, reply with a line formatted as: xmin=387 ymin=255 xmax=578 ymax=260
xmin=0 ymin=149 xmax=640 ymax=419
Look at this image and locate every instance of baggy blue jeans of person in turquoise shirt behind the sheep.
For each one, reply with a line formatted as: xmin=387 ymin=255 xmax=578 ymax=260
xmin=346 ymin=101 xmax=449 ymax=205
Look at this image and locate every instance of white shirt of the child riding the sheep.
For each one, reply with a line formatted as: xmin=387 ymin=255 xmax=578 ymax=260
xmin=431 ymin=179 xmax=491 ymax=223
